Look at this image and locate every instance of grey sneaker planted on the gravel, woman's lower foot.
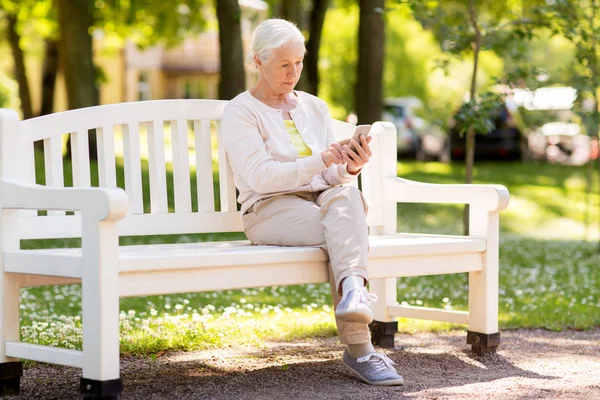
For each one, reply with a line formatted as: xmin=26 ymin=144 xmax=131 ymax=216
xmin=344 ymin=350 xmax=404 ymax=386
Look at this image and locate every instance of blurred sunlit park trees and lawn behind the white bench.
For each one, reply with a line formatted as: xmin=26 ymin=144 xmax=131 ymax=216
xmin=0 ymin=0 xmax=600 ymax=358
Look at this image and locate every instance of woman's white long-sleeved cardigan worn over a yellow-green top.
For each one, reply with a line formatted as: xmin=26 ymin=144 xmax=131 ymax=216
xmin=222 ymin=91 xmax=356 ymax=213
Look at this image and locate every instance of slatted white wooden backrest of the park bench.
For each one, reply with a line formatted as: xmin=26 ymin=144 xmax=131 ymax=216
xmin=0 ymin=100 xmax=395 ymax=239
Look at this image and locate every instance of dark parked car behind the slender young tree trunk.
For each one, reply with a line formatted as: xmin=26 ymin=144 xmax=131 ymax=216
xmin=450 ymin=103 xmax=528 ymax=160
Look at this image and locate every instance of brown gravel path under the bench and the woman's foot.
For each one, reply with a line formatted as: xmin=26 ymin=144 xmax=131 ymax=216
xmin=8 ymin=329 xmax=600 ymax=400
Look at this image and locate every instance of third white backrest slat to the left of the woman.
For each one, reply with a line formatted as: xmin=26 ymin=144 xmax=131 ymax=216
xmin=171 ymin=120 xmax=192 ymax=213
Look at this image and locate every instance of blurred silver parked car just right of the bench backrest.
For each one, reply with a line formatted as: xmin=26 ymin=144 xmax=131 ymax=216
xmin=383 ymin=97 xmax=450 ymax=162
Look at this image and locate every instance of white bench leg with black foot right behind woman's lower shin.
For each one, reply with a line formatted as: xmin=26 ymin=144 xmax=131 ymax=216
xmin=369 ymin=278 xmax=398 ymax=348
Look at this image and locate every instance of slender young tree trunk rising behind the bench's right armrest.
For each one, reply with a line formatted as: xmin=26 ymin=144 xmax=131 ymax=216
xmin=463 ymin=0 xmax=482 ymax=235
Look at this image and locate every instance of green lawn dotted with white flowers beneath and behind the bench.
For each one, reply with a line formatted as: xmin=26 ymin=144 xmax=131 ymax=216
xmin=16 ymin=155 xmax=600 ymax=354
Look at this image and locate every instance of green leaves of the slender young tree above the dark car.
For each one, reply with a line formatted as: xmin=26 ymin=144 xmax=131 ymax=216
xmin=397 ymin=0 xmax=550 ymax=142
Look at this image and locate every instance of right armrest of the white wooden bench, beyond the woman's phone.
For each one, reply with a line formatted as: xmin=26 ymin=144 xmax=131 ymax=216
xmin=384 ymin=177 xmax=510 ymax=211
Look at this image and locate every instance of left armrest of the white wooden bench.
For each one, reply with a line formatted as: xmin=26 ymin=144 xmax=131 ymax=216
xmin=0 ymin=179 xmax=128 ymax=221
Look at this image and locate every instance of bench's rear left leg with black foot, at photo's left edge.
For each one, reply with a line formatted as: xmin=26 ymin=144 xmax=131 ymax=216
xmin=0 ymin=210 xmax=23 ymax=397
